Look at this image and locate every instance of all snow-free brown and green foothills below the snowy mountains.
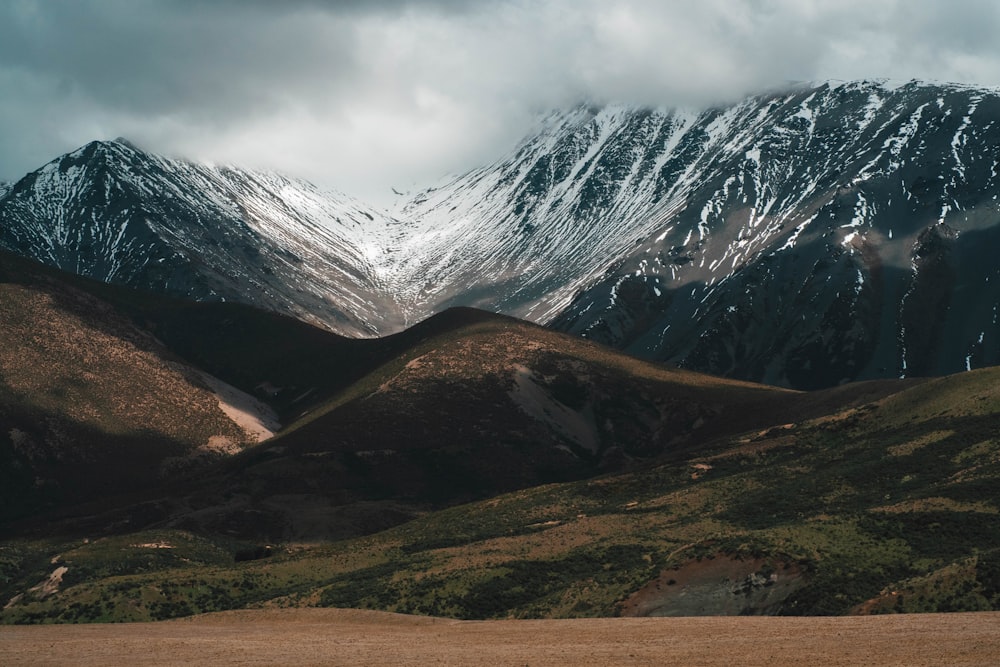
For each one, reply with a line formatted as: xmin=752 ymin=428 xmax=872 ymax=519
xmin=0 ymin=250 xmax=1000 ymax=623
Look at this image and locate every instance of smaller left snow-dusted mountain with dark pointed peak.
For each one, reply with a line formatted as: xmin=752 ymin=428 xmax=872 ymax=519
xmin=0 ymin=140 xmax=395 ymax=335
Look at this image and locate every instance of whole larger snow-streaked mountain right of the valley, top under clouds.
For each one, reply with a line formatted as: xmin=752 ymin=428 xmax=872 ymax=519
xmin=384 ymin=81 xmax=1000 ymax=387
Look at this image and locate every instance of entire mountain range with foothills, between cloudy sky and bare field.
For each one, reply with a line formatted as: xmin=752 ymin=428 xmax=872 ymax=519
xmin=0 ymin=82 xmax=1000 ymax=623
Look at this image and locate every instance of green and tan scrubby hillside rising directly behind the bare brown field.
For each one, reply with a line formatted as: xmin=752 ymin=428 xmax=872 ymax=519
xmin=3 ymin=358 xmax=1000 ymax=622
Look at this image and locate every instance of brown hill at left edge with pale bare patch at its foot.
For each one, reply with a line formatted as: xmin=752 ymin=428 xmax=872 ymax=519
xmin=0 ymin=259 xmax=275 ymax=517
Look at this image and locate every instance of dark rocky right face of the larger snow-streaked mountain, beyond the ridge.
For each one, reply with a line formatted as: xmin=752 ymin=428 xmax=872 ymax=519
xmin=552 ymin=82 xmax=1000 ymax=388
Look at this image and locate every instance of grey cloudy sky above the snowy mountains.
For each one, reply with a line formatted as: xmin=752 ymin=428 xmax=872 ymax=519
xmin=0 ymin=0 xmax=1000 ymax=201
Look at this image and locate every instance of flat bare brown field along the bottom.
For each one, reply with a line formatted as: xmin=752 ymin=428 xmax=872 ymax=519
xmin=0 ymin=609 xmax=1000 ymax=667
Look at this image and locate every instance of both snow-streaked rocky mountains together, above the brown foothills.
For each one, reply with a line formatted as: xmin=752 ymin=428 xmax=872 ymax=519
xmin=0 ymin=82 xmax=1000 ymax=388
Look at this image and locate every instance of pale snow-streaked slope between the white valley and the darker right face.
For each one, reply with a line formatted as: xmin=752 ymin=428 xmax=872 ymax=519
xmin=386 ymin=106 xmax=693 ymax=321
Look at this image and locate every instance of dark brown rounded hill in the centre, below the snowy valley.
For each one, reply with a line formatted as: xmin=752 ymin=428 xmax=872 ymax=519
xmin=50 ymin=309 xmax=916 ymax=541
